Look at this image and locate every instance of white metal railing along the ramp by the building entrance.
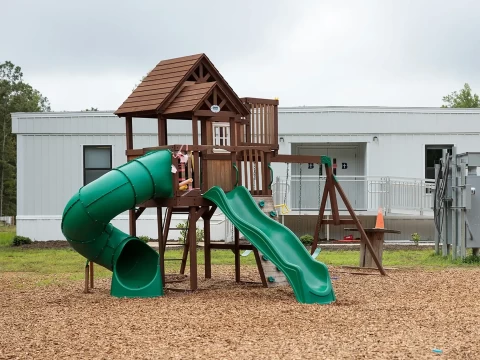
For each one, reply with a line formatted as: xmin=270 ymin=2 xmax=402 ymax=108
xmin=272 ymin=175 xmax=435 ymax=215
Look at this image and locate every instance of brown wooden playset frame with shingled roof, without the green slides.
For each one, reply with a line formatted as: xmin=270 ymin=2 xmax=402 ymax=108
xmin=79 ymin=54 xmax=385 ymax=291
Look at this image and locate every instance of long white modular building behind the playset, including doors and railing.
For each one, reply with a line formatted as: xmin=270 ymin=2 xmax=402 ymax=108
xmin=12 ymin=107 xmax=480 ymax=240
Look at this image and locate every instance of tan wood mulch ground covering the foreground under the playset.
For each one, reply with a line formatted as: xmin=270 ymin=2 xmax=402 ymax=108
xmin=0 ymin=266 xmax=480 ymax=359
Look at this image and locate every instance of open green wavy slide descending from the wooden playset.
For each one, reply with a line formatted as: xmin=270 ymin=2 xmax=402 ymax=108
xmin=203 ymin=186 xmax=335 ymax=304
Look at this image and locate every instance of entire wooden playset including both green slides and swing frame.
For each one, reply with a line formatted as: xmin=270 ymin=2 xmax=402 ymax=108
xmin=62 ymin=54 xmax=385 ymax=303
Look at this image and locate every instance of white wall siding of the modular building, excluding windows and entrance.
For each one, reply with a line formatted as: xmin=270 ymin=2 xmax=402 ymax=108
xmin=12 ymin=108 xmax=480 ymax=240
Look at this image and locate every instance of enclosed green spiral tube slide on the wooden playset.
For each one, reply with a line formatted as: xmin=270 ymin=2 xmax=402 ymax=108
xmin=61 ymin=150 xmax=173 ymax=297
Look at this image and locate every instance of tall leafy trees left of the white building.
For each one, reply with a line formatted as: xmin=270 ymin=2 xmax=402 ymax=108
xmin=0 ymin=61 xmax=50 ymax=216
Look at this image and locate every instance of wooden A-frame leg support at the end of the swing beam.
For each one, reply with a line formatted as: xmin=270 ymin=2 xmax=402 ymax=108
xmin=311 ymin=156 xmax=387 ymax=275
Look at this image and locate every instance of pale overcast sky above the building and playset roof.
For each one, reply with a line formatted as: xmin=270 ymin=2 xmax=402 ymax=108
xmin=0 ymin=0 xmax=480 ymax=111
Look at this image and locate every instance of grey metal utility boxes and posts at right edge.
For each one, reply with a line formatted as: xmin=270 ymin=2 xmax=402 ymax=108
xmin=434 ymin=147 xmax=480 ymax=259
